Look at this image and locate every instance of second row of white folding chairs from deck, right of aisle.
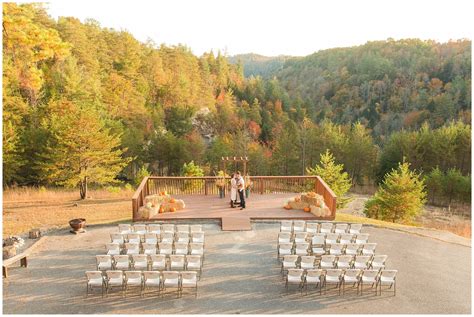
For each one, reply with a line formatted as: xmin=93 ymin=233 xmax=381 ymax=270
xmin=278 ymin=232 xmax=369 ymax=244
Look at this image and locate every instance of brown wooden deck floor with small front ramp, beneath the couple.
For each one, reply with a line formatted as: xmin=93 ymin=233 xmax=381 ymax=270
xmin=147 ymin=193 xmax=317 ymax=231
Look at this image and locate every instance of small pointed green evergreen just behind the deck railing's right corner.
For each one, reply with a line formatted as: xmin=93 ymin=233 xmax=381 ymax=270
xmin=306 ymin=150 xmax=352 ymax=208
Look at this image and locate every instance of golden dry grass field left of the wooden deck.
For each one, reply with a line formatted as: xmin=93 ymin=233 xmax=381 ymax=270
xmin=3 ymin=188 xmax=133 ymax=237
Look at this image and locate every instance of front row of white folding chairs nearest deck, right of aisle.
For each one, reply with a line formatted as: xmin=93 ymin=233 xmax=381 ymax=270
xmin=280 ymin=220 xmax=362 ymax=234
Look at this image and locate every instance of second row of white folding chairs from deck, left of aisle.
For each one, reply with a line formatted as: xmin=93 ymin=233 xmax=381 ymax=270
xmin=110 ymin=232 xmax=204 ymax=244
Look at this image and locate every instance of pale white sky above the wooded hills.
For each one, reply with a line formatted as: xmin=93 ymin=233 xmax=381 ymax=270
xmin=46 ymin=0 xmax=474 ymax=56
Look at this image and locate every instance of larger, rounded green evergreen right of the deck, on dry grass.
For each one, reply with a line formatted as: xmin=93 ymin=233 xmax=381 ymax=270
xmin=364 ymin=162 xmax=426 ymax=223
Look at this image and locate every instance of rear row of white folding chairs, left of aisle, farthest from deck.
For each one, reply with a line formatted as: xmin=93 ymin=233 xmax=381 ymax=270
xmin=86 ymin=270 xmax=198 ymax=297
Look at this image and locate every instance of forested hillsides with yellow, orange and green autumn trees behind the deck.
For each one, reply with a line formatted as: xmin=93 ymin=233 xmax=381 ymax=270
xmin=3 ymin=3 xmax=471 ymax=205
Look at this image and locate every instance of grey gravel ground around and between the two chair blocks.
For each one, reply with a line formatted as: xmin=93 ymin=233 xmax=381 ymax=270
xmin=3 ymin=223 xmax=471 ymax=314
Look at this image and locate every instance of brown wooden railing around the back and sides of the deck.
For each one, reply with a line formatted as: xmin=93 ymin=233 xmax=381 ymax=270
xmin=132 ymin=176 xmax=337 ymax=220
